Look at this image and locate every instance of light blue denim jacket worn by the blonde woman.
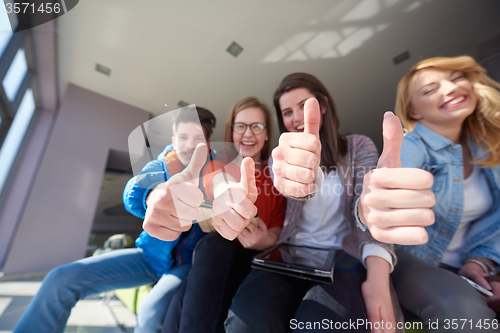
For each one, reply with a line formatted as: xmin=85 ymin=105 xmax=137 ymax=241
xmin=401 ymin=122 xmax=500 ymax=265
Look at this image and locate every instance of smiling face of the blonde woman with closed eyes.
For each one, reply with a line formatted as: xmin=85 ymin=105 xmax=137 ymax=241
xmin=408 ymin=68 xmax=477 ymax=133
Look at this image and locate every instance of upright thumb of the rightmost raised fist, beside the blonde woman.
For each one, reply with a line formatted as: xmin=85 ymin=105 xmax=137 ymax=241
xmin=377 ymin=111 xmax=404 ymax=168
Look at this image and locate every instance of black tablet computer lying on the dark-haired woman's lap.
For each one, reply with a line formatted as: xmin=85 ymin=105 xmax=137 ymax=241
xmin=252 ymin=243 xmax=337 ymax=283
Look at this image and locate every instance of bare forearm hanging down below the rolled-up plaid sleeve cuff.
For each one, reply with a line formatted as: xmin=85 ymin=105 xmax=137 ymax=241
xmin=361 ymin=256 xmax=396 ymax=333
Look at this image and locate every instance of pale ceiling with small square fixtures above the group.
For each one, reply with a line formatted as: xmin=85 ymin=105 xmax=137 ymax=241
xmin=57 ymin=0 xmax=500 ymax=147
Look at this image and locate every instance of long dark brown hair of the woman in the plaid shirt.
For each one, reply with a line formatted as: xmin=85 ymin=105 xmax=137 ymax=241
xmin=274 ymin=73 xmax=347 ymax=169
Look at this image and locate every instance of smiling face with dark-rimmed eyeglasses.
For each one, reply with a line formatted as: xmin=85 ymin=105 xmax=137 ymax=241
xmin=233 ymin=107 xmax=268 ymax=162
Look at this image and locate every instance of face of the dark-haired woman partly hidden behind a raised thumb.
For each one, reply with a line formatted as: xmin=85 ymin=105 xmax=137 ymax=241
xmin=279 ymin=88 xmax=325 ymax=132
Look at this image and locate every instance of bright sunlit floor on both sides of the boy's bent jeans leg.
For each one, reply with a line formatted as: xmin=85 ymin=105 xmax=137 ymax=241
xmin=0 ymin=278 xmax=136 ymax=333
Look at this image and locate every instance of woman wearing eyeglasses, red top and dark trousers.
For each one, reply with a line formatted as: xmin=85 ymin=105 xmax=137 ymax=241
xmin=163 ymin=97 xmax=286 ymax=333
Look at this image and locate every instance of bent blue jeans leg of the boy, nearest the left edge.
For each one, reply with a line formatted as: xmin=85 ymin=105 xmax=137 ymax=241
xmin=14 ymin=249 xmax=189 ymax=333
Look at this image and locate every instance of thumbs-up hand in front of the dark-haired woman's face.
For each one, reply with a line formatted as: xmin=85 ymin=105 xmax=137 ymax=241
xmin=272 ymin=98 xmax=321 ymax=197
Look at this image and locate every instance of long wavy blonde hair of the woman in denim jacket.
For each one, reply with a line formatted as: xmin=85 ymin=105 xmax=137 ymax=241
xmin=395 ymin=56 xmax=500 ymax=167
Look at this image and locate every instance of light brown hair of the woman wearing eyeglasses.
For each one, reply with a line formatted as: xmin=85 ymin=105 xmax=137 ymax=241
xmin=224 ymin=97 xmax=273 ymax=162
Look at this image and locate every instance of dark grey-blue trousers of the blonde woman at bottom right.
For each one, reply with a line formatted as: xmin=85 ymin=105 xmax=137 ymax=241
xmin=392 ymin=250 xmax=498 ymax=333
